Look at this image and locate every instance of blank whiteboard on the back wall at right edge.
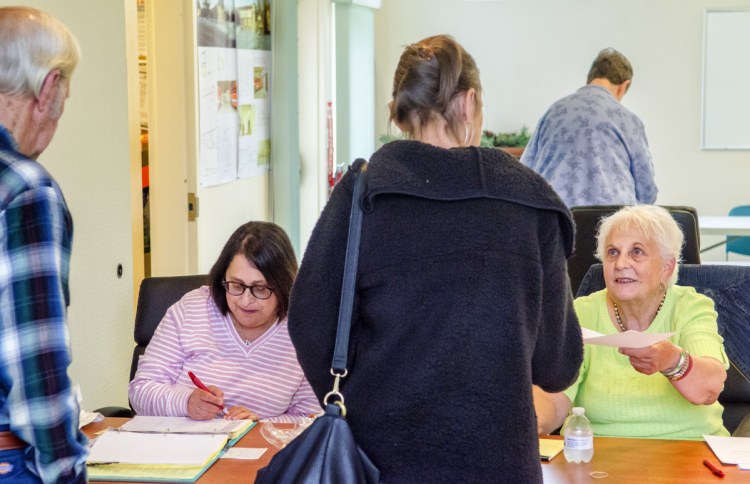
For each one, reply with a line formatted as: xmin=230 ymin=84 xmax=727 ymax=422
xmin=701 ymin=9 xmax=750 ymax=150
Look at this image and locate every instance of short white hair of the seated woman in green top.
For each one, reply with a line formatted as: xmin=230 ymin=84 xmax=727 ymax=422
xmin=596 ymin=205 xmax=685 ymax=287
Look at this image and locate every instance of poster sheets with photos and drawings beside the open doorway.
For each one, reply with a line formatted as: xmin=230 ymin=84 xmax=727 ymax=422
xmin=196 ymin=0 xmax=271 ymax=186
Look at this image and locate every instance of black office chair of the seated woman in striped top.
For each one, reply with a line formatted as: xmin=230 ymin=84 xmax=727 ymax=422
xmin=96 ymin=275 xmax=208 ymax=417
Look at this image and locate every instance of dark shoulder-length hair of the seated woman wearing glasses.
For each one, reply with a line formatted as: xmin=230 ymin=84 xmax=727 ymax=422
xmin=208 ymin=222 xmax=297 ymax=320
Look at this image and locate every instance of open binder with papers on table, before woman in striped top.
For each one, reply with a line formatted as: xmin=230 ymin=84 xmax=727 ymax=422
xmin=87 ymin=416 xmax=256 ymax=482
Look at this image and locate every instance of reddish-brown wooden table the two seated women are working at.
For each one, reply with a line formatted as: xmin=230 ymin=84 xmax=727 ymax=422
xmin=88 ymin=418 xmax=750 ymax=484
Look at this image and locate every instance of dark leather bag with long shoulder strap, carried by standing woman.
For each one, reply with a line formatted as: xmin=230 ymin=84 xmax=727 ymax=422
xmin=255 ymin=160 xmax=380 ymax=484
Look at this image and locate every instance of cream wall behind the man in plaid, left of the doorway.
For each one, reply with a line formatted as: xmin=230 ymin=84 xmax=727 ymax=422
xmin=0 ymin=0 xmax=143 ymax=409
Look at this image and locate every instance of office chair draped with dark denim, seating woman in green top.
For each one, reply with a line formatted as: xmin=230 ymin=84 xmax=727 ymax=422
xmin=577 ymin=264 xmax=750 ymax=437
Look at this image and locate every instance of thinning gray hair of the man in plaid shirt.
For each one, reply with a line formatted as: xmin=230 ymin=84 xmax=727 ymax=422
xmin=0 ymin=7 xmax=81 ymax=97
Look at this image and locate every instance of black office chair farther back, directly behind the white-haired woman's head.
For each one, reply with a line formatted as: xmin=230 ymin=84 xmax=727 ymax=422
xmin=568 ymin=205 xmax=701 ymax=294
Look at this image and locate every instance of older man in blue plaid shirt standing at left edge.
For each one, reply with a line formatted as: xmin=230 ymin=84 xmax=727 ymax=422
xmin=0 ymin=7 xmax=88 ymax=483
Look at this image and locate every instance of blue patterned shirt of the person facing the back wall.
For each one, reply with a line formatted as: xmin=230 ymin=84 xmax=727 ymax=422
xmin=521 ymin=85 xmax=658 ymax=207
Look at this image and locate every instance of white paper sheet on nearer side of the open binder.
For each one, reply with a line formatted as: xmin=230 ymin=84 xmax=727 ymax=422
xmin=87 ymin=430 xmax=227 ymax=466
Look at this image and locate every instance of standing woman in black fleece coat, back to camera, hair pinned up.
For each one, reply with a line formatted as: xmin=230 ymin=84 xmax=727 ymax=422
xmin=289 ymin=35 xmax=582 ymax=483
